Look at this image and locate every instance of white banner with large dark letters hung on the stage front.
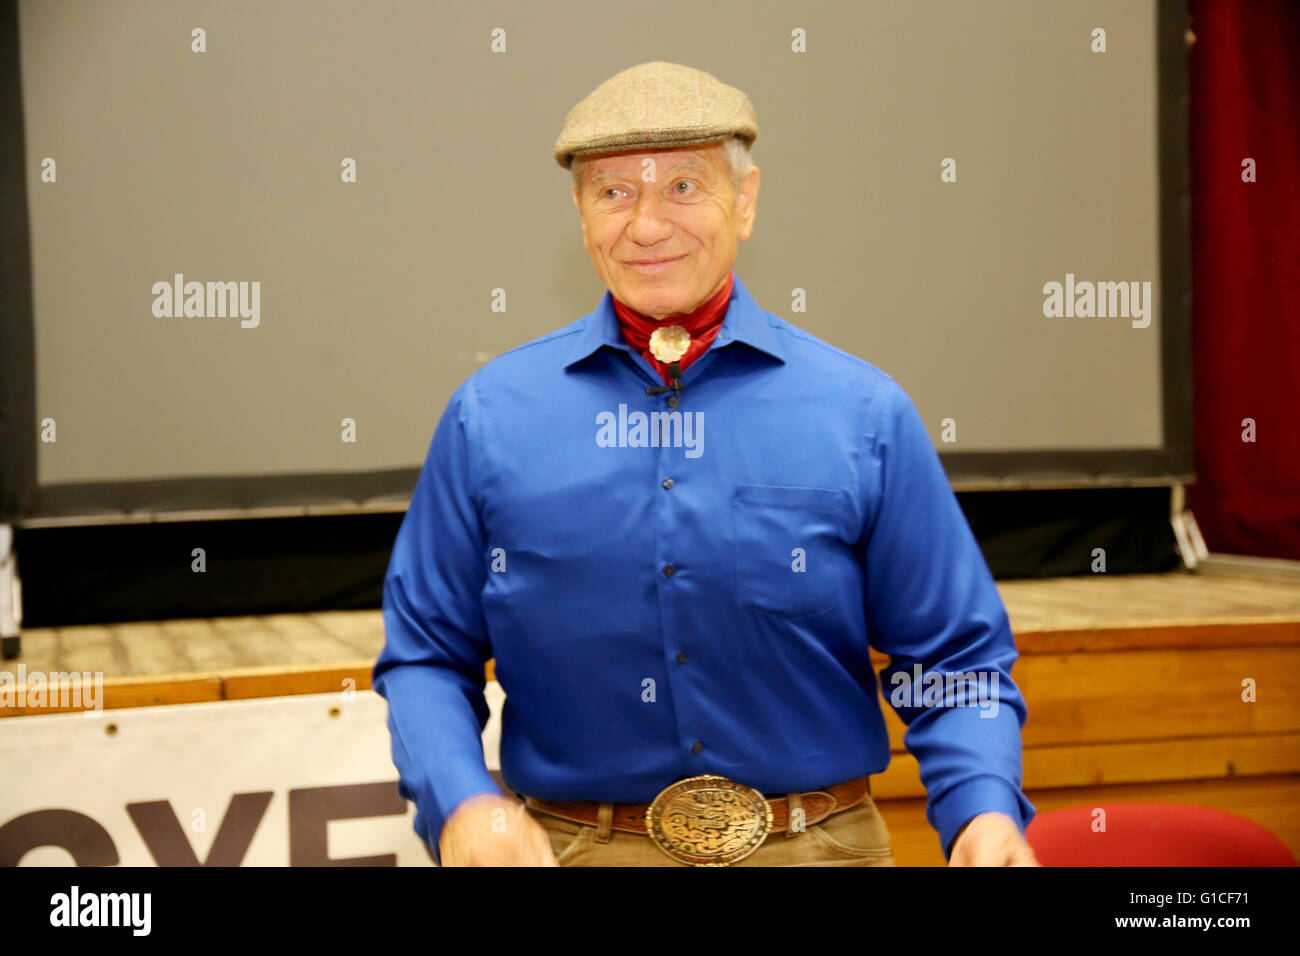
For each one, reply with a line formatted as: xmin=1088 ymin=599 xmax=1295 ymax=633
xmin=0 ymin=682 xmax=504 ymax=866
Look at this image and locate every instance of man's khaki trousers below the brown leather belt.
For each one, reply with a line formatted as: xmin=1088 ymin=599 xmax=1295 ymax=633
xmin=524 ymin=793 xmax=894 ymax=866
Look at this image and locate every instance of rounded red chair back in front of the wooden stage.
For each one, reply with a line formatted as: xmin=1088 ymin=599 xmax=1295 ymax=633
xmin=1024 ymin=804 xmax=1296 ymax=866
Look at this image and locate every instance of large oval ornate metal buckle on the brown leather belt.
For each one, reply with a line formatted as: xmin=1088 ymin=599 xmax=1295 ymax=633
xmin=646 ymin=774 xmax=772 ymax=866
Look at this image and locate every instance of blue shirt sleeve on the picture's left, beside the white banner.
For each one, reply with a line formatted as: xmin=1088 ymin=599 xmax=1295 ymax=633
xmin=373 ymin=381 xmax=499 ymax=862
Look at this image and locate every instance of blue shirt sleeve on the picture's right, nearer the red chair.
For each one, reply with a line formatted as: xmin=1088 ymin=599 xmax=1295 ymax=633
xmin=866 ymin=378 xmax=1035 ymax=856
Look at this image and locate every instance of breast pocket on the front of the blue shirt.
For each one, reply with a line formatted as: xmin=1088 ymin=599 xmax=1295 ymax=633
xmin=732 ymin=485 xmax=849 ymax=618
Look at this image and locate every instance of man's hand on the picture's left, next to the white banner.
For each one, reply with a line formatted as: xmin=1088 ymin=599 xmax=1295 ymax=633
xmin=438 ymin=793 xmax=559 ymax=866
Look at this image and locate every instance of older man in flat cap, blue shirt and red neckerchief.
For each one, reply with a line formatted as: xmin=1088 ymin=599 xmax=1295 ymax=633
xmin=374 ymin=62 xmax=1034 ymax=866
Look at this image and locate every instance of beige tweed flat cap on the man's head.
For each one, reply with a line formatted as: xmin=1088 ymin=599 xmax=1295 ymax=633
xmin=555 ymin=60 xmax=758 ymax=169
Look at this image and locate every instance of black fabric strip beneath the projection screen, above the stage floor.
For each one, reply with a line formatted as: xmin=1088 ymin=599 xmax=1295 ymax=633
xmin=16 ymin=488 xmax=1179 ymax=627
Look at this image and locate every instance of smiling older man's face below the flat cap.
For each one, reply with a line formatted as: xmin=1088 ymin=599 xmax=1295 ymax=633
xmin=573 ymin=144 xmax=758 ymax=320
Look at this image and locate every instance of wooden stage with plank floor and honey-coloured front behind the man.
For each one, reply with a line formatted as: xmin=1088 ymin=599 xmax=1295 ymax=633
xmin=0 ymin=572 xmax=1300 ymax=865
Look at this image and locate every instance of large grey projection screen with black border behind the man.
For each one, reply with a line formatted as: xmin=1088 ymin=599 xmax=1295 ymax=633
xmin=4 ymin=0 xmax=1191 ymax=520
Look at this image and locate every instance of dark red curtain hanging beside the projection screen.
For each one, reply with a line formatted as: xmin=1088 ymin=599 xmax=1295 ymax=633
xmin=1188 ymin=0 xmax=1300 ymax=559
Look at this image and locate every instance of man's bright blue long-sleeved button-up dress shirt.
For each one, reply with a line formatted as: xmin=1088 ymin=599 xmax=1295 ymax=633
xmin=374 ymin=270 xmax=1035 ymax=853
